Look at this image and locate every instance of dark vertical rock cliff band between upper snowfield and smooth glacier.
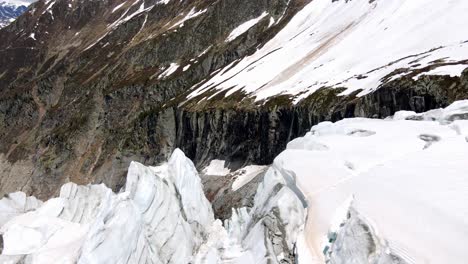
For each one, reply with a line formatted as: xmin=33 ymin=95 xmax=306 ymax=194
xmin=126 ymin=71 xmax=468 ymax=165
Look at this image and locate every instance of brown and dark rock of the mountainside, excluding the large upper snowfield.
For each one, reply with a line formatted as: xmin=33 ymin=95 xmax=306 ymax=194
xmin=0 ymin=0 xmax=468 ymax=199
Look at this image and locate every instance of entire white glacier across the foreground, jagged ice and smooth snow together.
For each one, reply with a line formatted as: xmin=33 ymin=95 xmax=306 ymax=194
xmin=0 ymin=100 xmax=468 ymax=264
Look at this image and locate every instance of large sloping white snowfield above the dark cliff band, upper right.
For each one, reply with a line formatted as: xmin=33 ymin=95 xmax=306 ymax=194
xmin=190 ymin=0 xmax=468 ymax=102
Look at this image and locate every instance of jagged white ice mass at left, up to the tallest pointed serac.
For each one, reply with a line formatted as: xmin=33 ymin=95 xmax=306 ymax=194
xmin=0 ymin=150 xmax=214 ymax=264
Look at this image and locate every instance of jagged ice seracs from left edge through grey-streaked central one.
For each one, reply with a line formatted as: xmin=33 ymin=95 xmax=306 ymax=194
xmin=0 ymin=150 xmax=305 ymax=264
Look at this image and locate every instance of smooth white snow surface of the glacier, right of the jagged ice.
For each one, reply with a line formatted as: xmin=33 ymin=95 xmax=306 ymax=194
xmin=274 ymin=100 xmax=468 ymax=263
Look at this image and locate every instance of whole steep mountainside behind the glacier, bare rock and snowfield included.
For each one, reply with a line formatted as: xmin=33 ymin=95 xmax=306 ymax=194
xmin=0 ymin=0 xmax=468 ymax=198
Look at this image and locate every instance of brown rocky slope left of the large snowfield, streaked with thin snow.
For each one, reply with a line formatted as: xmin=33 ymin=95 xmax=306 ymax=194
xmin=0 ymin=0 xmax=304 ymax=198
